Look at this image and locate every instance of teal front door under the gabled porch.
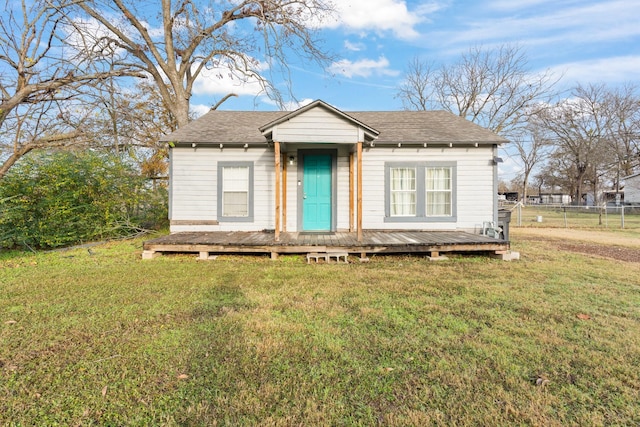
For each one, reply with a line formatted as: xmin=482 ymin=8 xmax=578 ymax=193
xmin=302 ymin=154 xmax=332 ymax=231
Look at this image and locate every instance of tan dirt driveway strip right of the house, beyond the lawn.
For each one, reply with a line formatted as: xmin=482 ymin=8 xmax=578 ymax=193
xmin=511 ymin=228 xmax=640 ymax=262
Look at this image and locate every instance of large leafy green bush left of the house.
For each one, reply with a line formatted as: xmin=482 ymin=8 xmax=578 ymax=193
xmin=0 ymin=151 xmax=166 ymax=248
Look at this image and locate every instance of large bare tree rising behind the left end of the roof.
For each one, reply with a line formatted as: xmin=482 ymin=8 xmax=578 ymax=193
xmin=77 ymin=0 xmax=333 ymax=126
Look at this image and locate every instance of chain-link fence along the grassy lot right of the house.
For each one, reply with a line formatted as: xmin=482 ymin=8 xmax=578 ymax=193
xmin=500 ymin=202 xmax=640 ymax=230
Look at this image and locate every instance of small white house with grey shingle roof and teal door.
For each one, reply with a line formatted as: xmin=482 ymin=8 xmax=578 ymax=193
xmin=161 ymin=101 xmax=507 ymax=239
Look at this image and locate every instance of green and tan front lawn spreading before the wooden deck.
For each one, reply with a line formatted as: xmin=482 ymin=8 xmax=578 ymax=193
xmin=0 ymin=229 xmax=640 ymax=425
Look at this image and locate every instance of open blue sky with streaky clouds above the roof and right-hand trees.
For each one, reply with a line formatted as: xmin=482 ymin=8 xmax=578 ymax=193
xmin=192 ymin=0 xmax=640 ymax=115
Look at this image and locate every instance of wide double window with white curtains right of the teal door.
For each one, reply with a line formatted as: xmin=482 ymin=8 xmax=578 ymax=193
xmin=385 ymin=162 xmax=456 ymax=222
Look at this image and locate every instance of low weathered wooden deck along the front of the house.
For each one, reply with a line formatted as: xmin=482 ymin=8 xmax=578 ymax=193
xmin=143 ymin=231 xmax=509 ymax=259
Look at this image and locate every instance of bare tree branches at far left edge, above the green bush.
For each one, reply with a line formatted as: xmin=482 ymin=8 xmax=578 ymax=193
xmin=0 ymin=0 xmax=139 ymax=179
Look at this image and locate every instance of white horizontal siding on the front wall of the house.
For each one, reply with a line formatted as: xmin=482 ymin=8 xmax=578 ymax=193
xmin=170 ymin=144 xmax=497 ymax=232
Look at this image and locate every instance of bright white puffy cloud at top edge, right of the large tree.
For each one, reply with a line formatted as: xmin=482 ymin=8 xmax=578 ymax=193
xmin=321 ymin=0 xmax=442 ymax=39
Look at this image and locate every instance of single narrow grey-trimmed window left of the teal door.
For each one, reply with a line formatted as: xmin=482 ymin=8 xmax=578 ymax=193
xmin=218 ymin=162 xmax=253 ymax=222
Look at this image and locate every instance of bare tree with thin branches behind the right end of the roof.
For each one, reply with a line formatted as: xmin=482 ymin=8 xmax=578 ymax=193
xmin=397 ymin=45 xmax=557 ymax=137
